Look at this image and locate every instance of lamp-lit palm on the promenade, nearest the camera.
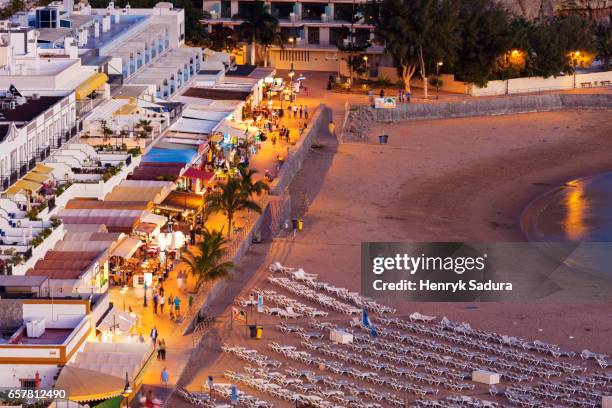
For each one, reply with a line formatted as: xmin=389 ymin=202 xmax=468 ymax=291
xmin=181 ymin=229 xmax=234 ymax=292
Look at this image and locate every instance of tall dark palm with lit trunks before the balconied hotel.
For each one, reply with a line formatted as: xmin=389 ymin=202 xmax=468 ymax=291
xmin=232 ymin=1 xmax=282 ymax=65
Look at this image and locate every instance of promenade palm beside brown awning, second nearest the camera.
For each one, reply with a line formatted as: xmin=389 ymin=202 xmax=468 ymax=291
xmin=206 ymin=177 xmax=261 ymax=239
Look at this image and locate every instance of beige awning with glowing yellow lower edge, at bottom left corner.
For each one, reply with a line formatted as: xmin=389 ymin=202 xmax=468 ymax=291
xmin=55 ymin=365 xmax=125 ymax=402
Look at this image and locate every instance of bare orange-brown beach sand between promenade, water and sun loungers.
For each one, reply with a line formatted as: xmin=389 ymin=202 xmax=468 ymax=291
xmin=173 ymin=107 xmax=612 ymax=406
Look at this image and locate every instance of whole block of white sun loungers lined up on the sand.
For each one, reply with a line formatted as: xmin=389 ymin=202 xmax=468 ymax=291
xmin=216 ymin=264 xmax=612 ymax=408
